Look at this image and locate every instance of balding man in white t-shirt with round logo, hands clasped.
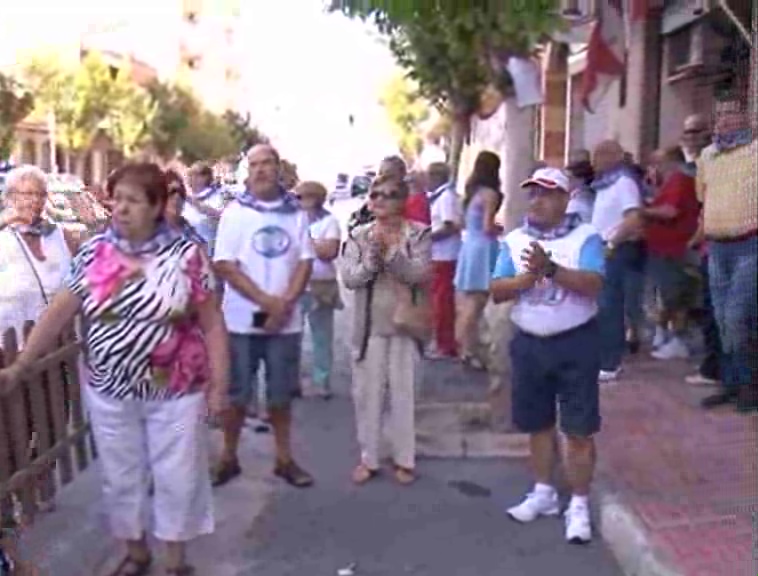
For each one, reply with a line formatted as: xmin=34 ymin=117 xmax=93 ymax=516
xmin=214 ymin=145 xmax=315 ymax=487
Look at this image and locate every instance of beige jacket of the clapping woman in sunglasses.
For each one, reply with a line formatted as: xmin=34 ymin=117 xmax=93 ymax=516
xmin=338 ymin=222 xmax=432 ymax=360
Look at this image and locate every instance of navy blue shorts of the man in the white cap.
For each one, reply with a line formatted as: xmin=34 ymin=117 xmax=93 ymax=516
xmin=510 ymin=319 xmax=601 ymax=437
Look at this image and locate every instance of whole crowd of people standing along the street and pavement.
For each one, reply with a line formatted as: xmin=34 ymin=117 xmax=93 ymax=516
xmin=0 ymin=89 xmax=758 ymax=576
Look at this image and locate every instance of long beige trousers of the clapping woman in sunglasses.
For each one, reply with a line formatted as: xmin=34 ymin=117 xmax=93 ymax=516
xmin=353 ymin=336 xmax=419 ymax=470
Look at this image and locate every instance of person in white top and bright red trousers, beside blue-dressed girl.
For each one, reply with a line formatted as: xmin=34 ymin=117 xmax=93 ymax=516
xmin=427 ymin=162 xmax=463 ymax=358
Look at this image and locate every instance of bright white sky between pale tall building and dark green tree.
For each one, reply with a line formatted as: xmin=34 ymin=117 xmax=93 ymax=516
xmin=241 ymin=0 xmax=395 ymax=179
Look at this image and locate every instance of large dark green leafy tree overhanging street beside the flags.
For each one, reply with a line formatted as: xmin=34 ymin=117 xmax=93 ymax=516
xmin=330 ymin=0 xmax=560 ymax=167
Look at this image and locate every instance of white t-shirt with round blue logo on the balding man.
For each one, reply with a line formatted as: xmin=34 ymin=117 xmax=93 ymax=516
xmin=213 ymin=200 xmax=315 ymax=334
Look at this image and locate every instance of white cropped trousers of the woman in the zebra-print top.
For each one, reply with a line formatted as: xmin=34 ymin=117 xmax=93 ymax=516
xmin=84 ymin=386 xmax=214 ymax=542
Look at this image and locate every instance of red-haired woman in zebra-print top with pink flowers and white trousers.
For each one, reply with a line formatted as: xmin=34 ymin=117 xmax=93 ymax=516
xmin=0 ymin=164 xmax=229 ymax=576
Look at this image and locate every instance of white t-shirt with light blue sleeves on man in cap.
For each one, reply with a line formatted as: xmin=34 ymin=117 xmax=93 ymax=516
xmin=492 ymin=224 xmax=605 ymax=336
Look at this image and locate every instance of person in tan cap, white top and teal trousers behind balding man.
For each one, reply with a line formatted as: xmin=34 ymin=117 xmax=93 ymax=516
xmin=295 ymin=182 xmax=342 ymax=400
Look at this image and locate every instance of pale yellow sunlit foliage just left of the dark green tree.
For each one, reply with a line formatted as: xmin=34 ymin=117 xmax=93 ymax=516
xmin=380 ymin=74 xmax=429 ymax=158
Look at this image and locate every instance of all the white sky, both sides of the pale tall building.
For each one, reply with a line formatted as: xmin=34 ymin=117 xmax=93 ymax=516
xmin=0 ymin=0 xmax=395 ymax=182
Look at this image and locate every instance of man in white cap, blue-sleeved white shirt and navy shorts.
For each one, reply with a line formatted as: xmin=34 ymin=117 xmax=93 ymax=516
xmin=490 ymin=168 xmax=605 ymax=544
